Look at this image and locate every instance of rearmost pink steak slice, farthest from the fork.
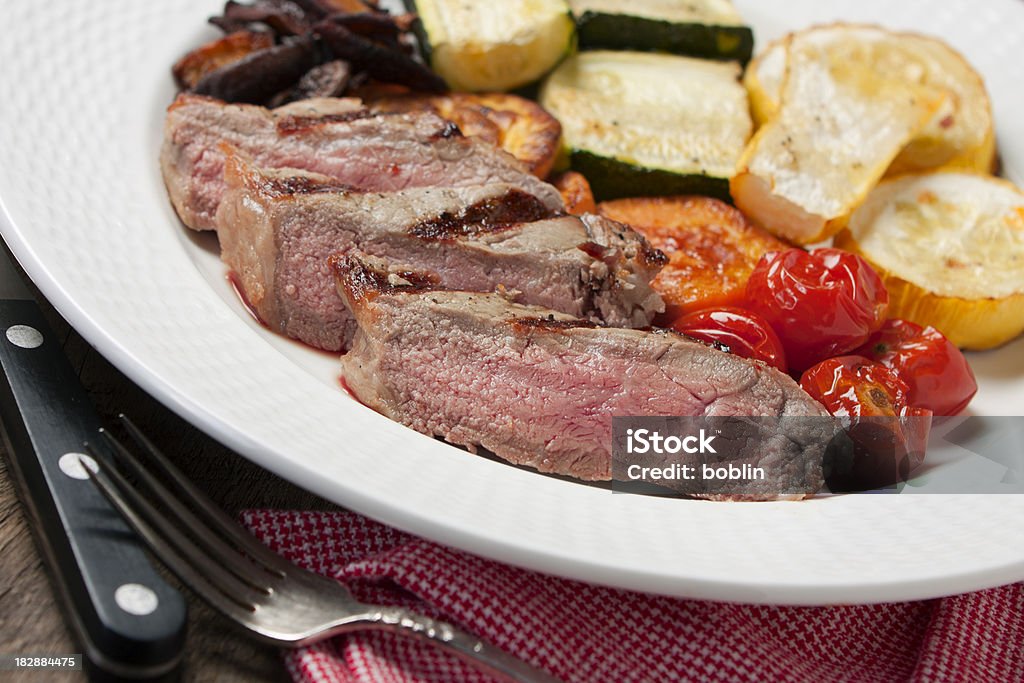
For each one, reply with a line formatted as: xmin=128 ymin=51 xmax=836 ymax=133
xmin=160 ymin=94 xmax=560 ymax=230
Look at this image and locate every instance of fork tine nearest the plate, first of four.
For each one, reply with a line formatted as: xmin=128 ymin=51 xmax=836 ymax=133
xmin=116 ymin=414 xmax=290 ymax=578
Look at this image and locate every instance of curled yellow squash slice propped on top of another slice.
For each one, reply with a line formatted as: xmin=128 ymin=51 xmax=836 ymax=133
xmin=730 ymin=39 xmax=945 ymax=245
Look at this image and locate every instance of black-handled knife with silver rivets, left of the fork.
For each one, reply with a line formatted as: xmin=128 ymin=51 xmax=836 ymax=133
xmin=0 ymin=240 xmax=186 ymax=681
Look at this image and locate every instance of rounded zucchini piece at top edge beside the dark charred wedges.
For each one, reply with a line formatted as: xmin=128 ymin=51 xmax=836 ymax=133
xmin=406 ymin=0 xmax=575 ymax=92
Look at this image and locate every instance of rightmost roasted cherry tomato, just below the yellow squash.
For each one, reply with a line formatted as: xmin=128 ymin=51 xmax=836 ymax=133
xmin=856 ymin=319 xmax=978 ymax=415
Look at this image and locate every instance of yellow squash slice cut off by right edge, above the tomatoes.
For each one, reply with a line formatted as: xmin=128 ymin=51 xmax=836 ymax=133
xmin=836 ymin=172 xmax=1024 ymax=349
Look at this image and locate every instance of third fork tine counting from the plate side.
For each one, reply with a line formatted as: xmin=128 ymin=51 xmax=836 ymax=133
xmin=86 ymin=444 xmax=260 ymax=611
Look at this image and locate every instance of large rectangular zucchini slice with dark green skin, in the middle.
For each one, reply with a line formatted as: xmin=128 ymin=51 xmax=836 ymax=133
xmin=541 ymin=50 xmax=752 ymax=200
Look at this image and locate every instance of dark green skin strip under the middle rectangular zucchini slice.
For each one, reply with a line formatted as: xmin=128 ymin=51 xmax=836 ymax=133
xmin=570 ymin=150 xmax=732 ymax=204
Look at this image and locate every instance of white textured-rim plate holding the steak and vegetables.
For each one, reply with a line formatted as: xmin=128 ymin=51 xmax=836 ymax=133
xmin=0 ymin=0 xmax=1024 ymax=603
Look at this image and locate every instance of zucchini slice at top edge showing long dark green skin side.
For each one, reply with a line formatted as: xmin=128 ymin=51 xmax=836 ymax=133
xmin=569 ymin=0 xmax=754 ymax=65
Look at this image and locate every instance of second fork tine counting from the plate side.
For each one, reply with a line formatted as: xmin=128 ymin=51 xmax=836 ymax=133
xmin=94 ymin=429 xmax=284 ymax=594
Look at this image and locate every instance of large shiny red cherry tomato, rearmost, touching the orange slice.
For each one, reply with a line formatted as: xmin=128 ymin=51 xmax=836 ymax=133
xmin=746 ymin=249 xmax=889 ymax=372
